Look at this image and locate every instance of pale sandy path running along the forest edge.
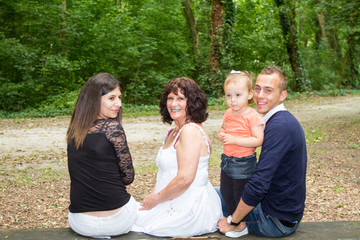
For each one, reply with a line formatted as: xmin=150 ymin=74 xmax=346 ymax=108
xmin=0 ymin=95 xmax=360 ymax=158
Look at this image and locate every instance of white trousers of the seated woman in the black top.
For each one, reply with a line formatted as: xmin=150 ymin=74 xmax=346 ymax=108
xmin=68 ymin=197 xmax=138 ymax=239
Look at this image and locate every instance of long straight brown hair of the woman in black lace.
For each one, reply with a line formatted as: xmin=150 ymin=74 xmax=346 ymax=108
xmin=67 ymin=73 xmax=122 ymax=149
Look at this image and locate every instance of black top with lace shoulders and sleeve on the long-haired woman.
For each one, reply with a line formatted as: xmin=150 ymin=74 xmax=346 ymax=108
xmin=68 ymin=119 xmax=135 ymax=213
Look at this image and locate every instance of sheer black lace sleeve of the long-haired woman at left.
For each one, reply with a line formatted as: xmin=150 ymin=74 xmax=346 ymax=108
xmin=105 ymin=121 xmax=135 ymax=185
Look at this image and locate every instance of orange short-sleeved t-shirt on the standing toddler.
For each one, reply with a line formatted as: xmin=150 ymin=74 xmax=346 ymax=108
xmin=223 ymin=107 xmax=264 ymax=158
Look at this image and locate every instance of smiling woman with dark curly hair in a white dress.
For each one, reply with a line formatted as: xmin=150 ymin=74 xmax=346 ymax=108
xmin=132 ymin=77 xmax=223 ymax=237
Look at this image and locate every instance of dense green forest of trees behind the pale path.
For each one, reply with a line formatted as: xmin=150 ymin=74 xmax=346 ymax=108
xmin=0 ymin=0 xmax=360 ymax=117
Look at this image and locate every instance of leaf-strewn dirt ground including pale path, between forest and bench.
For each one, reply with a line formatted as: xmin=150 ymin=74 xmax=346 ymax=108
xmin=0 ymin=95 xmax=360 ymax=229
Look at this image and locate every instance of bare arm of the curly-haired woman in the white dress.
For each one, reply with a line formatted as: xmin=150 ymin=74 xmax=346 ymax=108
xmin=140 ymin=125 xmax=202 ymax=210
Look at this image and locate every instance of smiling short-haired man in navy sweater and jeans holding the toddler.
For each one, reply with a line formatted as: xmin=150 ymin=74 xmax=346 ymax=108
xmin=218 ymin=66 xmax=307 ymax=237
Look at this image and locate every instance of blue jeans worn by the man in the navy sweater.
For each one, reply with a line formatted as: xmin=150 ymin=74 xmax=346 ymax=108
xmin=246 ymin=203 xmax=300 ymax=237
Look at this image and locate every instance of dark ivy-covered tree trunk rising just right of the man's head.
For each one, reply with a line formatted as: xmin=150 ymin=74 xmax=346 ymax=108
xmin=275 ymin=0 xmax=310 ymax=92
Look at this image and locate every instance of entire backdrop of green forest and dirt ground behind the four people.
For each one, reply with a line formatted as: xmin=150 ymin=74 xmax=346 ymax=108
xmin=0 ymin=0 xmax=360 ymax=229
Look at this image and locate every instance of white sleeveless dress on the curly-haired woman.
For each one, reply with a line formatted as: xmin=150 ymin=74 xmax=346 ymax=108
xmin=132 ymin=123 xmax=223 ymax=237
